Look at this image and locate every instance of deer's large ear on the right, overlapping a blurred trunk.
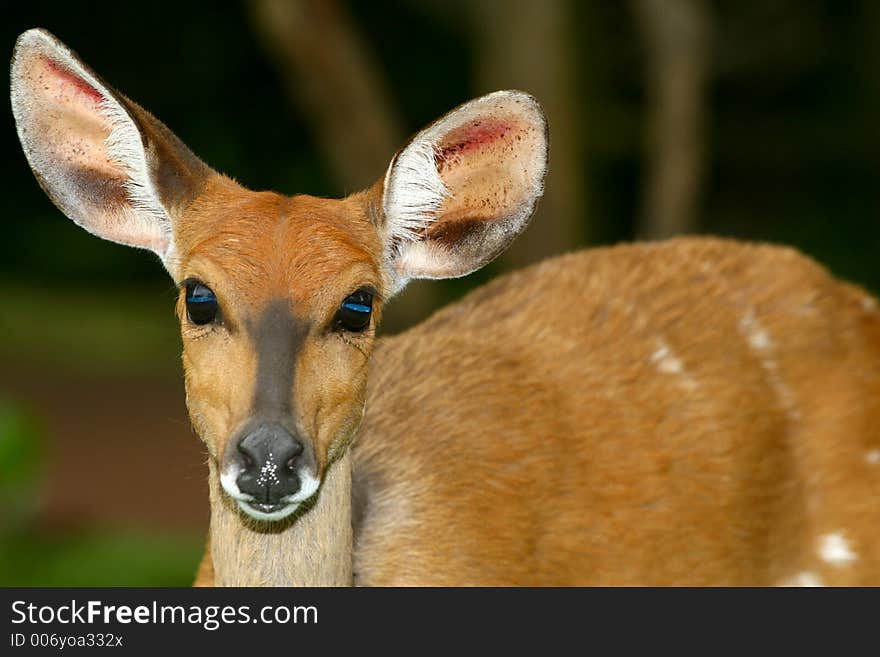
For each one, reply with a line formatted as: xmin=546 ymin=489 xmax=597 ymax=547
xmin=380 ymin=91 xmax=548 ymax=291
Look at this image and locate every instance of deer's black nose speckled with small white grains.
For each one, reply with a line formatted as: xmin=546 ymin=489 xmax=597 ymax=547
xmin=236 ymin=424 xmax=303 ymax=504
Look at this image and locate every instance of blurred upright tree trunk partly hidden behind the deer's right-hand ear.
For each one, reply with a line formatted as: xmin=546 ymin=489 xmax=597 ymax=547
xmin=467 ymin=0 xmax=588 ymax=267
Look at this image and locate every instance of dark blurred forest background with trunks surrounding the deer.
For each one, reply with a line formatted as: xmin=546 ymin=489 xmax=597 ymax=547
xmin=0 ymin=0 xmax=880 ymax=585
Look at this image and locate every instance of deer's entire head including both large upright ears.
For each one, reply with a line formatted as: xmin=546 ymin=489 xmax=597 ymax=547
xmin=11 ymin=30 xmax=547 ymax=520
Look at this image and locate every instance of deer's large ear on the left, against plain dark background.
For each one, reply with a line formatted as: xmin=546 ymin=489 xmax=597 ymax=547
xmin=11 ymin=29 xmax=212 ymax=275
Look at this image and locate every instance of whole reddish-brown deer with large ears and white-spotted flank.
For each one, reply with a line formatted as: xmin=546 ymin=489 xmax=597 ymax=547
xmin=11 ymin=29 xmax=880 ymax=586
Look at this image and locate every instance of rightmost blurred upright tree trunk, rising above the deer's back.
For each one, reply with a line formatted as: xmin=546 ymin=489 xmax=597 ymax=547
xmin=633 ymin=0 xmax=710 ymax=239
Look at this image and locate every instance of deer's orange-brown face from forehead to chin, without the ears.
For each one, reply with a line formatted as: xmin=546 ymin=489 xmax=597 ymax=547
xmin=176 ymin=187 xmax=386 ymax=520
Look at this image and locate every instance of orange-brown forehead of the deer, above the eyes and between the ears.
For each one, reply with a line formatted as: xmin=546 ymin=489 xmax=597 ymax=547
xmin=179 ymin=186 xmax=381 ymax=308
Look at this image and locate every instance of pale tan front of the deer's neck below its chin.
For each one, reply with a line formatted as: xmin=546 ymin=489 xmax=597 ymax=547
xmin=210 ymin=453 xmax=352 ymax=586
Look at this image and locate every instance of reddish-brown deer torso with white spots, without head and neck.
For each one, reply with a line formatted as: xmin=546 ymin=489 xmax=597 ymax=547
xmin=353 ymin=239 xmax=880 ymax=585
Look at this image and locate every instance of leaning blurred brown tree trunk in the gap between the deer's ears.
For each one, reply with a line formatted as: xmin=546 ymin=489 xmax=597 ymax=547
xmin=250 ymin=0 xmax=438 ymax=333
